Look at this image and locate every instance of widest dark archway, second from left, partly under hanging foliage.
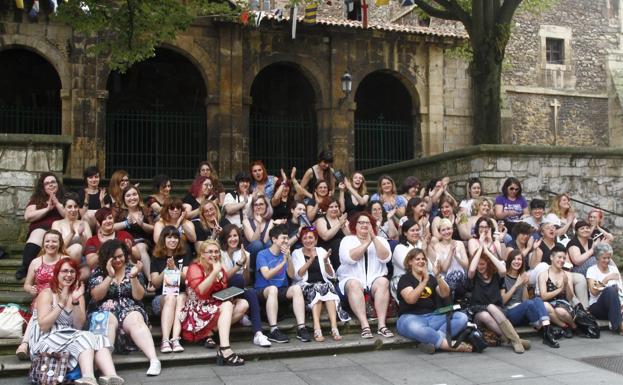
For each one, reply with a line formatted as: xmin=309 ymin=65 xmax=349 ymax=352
xmin=106 ymin=48 xmax=208 ymax=179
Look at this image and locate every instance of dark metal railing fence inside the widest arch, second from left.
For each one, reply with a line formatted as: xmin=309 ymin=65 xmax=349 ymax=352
xmin=106 ymin=111 xmax=208 ymax=179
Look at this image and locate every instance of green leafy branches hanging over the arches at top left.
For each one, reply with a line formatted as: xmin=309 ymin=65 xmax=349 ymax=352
xmin=56 ymin=0 xmax=240 ymax=72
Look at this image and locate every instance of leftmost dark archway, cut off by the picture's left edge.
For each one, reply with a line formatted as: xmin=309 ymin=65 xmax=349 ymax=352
xmin=0 ymin=48 xmax=61 ymax=135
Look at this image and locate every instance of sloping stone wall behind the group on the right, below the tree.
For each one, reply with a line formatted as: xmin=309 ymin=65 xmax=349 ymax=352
xmin=365 ymin=145 xmax=623 ymax=254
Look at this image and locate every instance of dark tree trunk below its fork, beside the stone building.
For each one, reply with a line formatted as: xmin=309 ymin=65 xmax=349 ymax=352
xmin=470 ymin=43 xmax=502 ymax=144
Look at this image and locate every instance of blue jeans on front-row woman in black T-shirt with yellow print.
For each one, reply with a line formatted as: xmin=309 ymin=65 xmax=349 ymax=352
xmin=396 ymin=312 xmax=467 ymax=349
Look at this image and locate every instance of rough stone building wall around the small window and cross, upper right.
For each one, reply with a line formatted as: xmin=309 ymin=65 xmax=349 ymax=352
xmin=503 ymin=0 xmax=620 ymax=146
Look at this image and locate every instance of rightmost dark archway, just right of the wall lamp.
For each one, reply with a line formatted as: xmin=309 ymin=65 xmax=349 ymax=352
xmin=355 ymin=71 xmax=415 ymax=170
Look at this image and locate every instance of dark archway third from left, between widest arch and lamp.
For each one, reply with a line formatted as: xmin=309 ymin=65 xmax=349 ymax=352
xmin=249 ymin=63 xmax=318 ymax=175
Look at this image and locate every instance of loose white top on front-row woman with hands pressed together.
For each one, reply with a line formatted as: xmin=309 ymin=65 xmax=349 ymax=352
xmin=337 ymin=235 xmax=392 ymax=293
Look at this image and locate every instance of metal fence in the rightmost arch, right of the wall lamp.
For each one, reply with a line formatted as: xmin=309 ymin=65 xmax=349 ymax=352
xmin=355 ymin=117 xmax=414 ymax=170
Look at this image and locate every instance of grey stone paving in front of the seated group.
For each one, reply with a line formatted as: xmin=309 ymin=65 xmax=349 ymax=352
xmin=0 ymin=333 xmax=623 ymax=385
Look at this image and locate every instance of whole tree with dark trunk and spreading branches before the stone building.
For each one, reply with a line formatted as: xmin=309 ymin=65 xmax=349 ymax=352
xmin=413 ymin=0 xmax=555 ymax=144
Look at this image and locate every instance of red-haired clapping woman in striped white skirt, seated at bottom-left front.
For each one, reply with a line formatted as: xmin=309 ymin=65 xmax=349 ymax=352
xmin=29 ymin=257 xmax=123 ymax=385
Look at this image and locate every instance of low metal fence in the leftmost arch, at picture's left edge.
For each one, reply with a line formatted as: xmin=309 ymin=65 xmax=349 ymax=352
xmin=0 ymin=106 xmax=61 ymax=135
